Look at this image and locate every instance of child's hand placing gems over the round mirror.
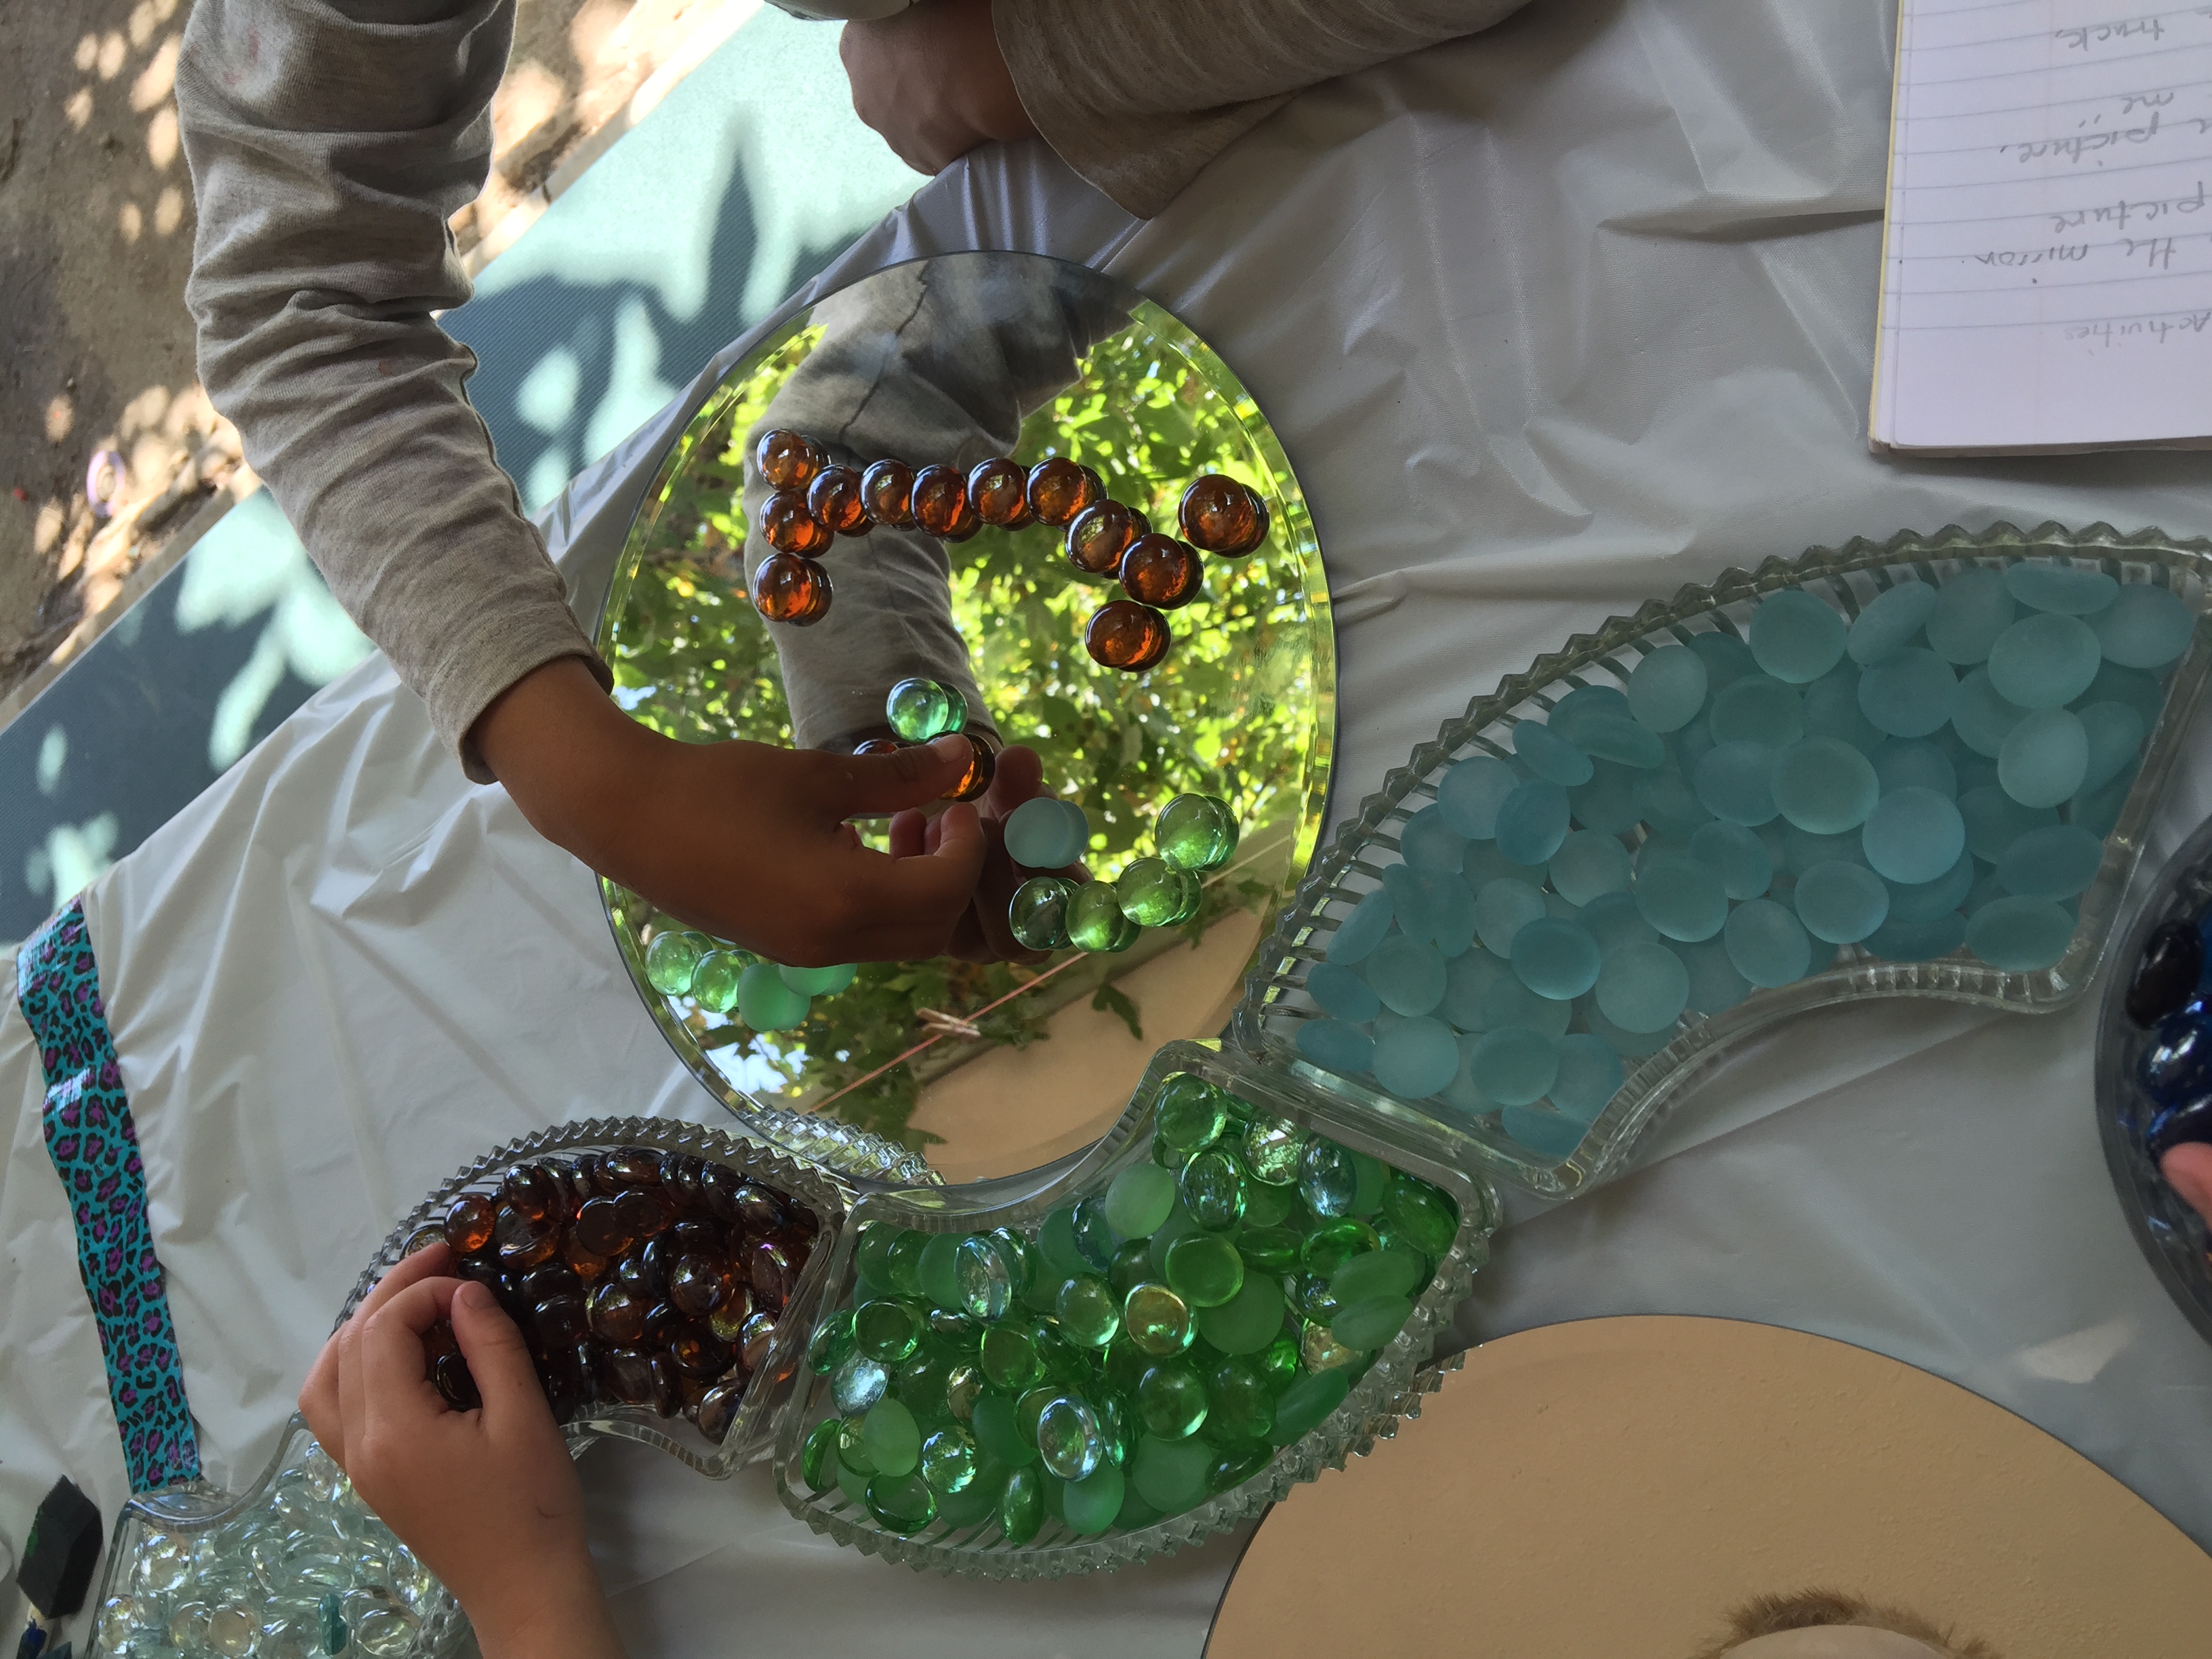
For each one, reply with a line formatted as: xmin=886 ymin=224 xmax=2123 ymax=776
xmin=476 ymin=657 xmax=984 ymax=966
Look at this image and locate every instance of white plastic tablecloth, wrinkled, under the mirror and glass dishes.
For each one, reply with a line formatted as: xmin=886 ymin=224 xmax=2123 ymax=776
xmin=0 ymin=0 xmax=2212 ymax=1657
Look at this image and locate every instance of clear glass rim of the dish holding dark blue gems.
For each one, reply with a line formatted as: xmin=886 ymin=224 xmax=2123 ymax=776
xmin=2097 ymin=823 xmax=2212 ymax=1343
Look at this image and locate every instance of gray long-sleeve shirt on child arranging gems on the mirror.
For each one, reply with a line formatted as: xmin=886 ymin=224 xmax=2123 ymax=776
xmin=177 ymin=0 xmax=1522 ymax=781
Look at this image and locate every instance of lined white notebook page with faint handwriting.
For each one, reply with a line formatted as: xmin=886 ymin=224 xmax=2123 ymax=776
xmin=1871 ymin=0 xmax=2212 ymax=453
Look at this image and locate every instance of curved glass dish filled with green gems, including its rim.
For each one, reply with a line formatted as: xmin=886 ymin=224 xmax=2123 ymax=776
xmin=774 ymin=1042 xmax=1498 ymax=1579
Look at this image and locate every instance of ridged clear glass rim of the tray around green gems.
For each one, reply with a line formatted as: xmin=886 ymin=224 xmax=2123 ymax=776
xmin=774 ymin=1042 xmax=1498 ymax=1579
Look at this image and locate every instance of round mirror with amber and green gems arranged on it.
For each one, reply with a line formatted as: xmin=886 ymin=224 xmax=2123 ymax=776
xmin=597 ymin=254 xmax=1336 ymax=1186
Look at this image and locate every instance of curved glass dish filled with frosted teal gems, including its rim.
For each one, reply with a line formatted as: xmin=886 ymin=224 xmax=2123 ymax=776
xmin=1237 ymin=525 xmax=2212 ymax=1197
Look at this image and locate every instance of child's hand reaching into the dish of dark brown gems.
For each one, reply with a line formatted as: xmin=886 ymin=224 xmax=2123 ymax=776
xmin=299 ymin=1246 xmax=621 ymax=1659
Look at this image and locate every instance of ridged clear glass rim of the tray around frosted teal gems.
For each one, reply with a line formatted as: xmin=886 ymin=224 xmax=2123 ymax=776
xmin=1237 ymin=525 xmax=2212 ymax=1197
